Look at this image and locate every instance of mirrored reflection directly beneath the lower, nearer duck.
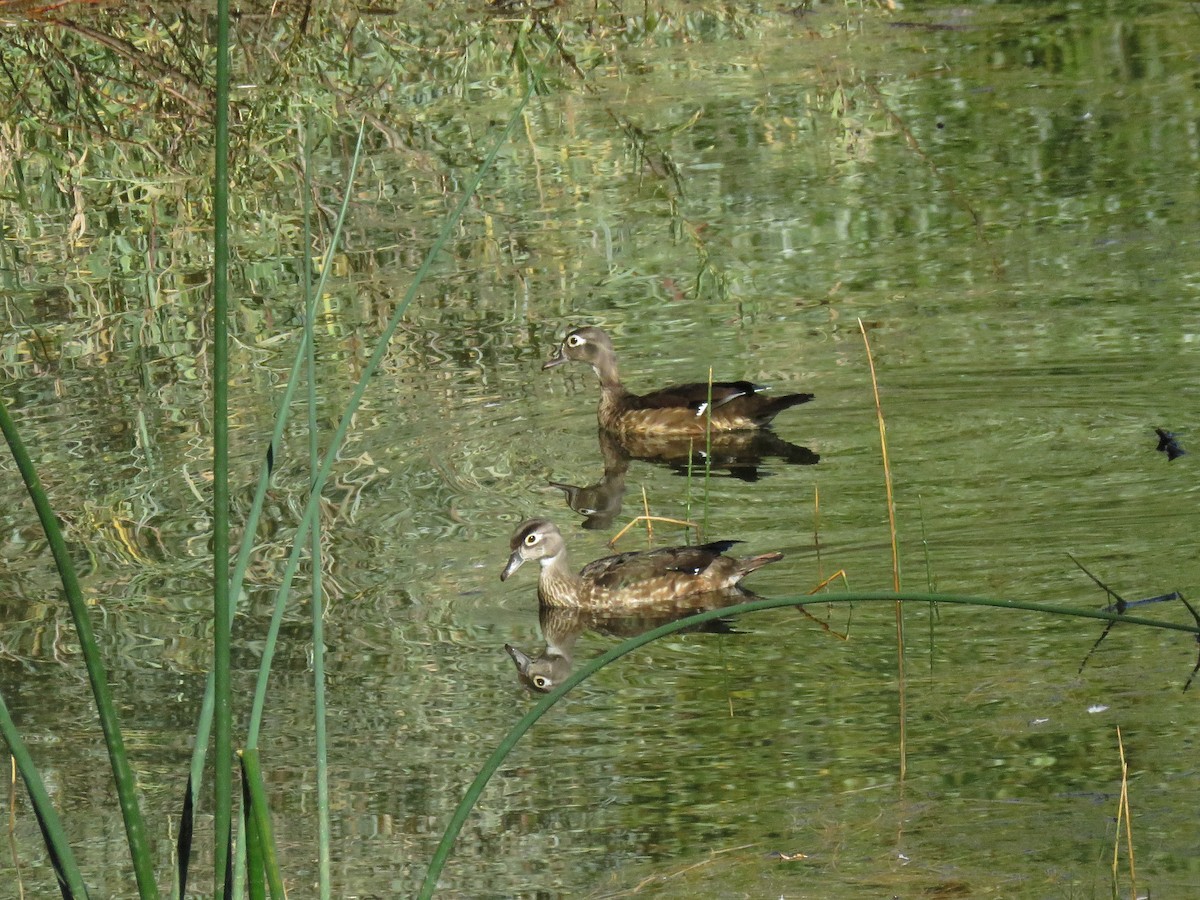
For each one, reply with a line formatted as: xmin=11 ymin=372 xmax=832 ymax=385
xmin=504 ymin=600 xmax=739 ymax=694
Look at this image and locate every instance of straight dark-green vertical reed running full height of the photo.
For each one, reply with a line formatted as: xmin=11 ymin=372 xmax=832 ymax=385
xmin=212 ymin=0 xmax=233 ymax=900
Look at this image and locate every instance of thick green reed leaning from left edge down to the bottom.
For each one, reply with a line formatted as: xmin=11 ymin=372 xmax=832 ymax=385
xmin=0 ymin=402 xmax=158 ymax=898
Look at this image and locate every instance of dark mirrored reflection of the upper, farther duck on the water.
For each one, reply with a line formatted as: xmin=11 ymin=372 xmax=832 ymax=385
xmin=548 ymin=428 xmax=821 ymax=529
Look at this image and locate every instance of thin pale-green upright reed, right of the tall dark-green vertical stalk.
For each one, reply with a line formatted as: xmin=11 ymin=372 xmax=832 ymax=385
xmin=301 ymin=116 xmax=332 ymax=900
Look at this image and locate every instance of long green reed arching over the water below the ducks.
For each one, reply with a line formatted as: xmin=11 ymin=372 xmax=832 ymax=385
xmin=418 ymin=592 xmax=1200 ymax=900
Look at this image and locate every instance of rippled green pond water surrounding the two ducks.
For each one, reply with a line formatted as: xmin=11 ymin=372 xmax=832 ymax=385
xmin=0 ymin=2 xmax=1200 ymax=898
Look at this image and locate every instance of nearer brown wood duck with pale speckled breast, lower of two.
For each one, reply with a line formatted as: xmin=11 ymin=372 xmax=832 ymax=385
xmin=500 ymin=518 xmax=784 ymax=610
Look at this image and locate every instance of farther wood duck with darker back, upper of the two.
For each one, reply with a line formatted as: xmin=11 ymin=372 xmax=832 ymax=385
xmin=542 ymin=325 xmax=812 ymax=437
